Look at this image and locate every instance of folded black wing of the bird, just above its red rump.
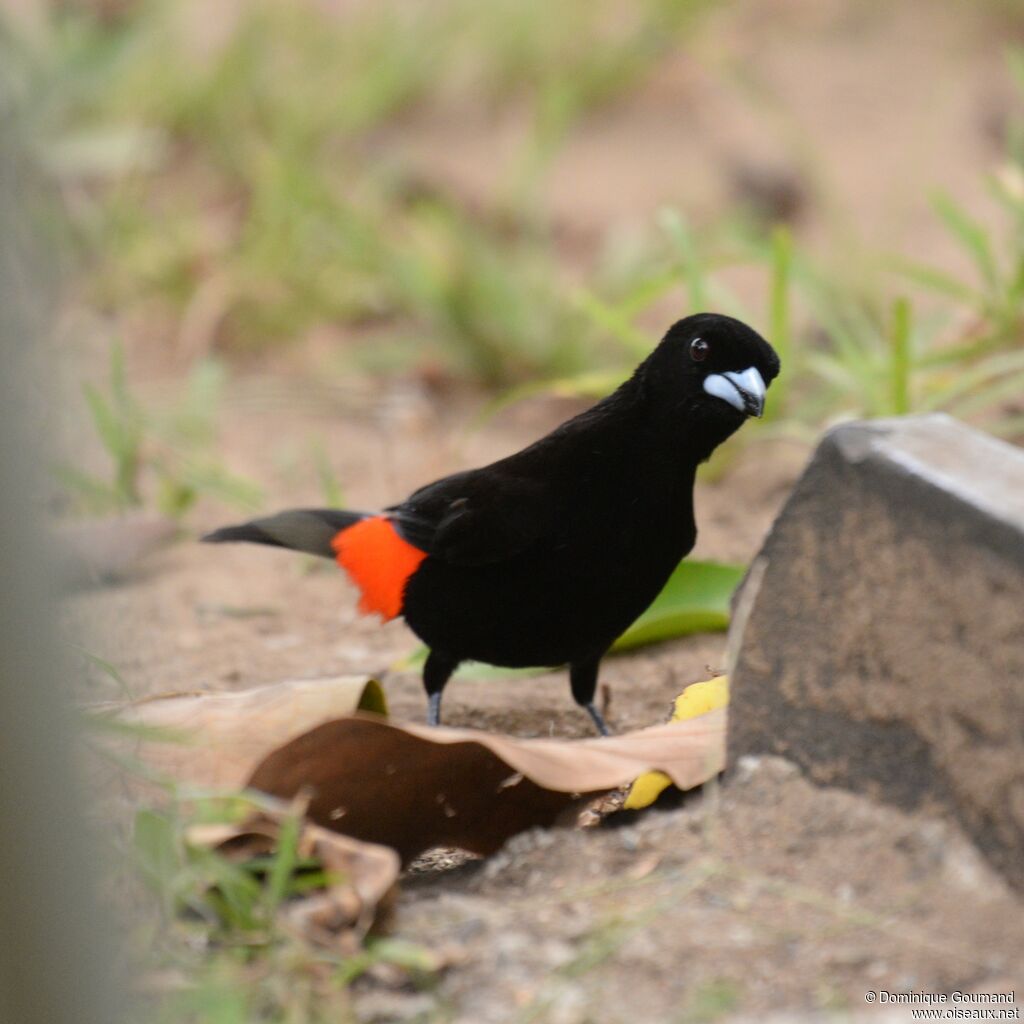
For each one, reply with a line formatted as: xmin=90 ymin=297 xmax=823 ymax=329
xmin=387 ymin=467 xmax=556 ymax=565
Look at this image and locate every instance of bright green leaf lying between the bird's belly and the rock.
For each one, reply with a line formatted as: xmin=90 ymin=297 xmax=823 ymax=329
xmin=611 ymin=561 xmax=745 ymax=650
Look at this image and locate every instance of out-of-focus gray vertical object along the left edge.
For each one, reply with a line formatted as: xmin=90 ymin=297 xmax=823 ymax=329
xmin=0 ymin=103 xmax=119 ymax=1024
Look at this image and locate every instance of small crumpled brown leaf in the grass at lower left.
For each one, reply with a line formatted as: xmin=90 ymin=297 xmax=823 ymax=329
xmin=188 ymin=805 xmax=399 ymax=953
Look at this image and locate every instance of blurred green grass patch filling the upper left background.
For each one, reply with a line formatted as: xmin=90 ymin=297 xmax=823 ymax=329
xmin=4 ymin=0 xmax=705 ymax=386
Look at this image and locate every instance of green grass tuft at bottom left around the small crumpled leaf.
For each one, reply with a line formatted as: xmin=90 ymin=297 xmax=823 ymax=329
xmin=131 ymin=794 xmax=440 ymax=1024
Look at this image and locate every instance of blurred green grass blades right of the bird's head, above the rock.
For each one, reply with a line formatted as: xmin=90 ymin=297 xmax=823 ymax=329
xmin=565 ymin=184 xmax=1024 ymax=439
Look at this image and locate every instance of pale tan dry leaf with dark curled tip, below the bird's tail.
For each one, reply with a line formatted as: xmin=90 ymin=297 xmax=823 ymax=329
xmin=108 ymin=676 xmax=387 ymax=790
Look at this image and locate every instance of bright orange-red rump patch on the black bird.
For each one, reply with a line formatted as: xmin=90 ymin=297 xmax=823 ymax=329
xmin=331 ymin=515 xmax=427 ymax=623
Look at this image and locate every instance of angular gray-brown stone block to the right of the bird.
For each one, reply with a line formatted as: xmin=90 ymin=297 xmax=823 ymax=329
xmin=729 ymin=416 xmax=1024 ymax=888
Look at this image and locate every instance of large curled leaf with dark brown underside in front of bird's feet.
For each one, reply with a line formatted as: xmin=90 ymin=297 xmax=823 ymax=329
xmin=248 ymin=709 xmax=726 ymax=863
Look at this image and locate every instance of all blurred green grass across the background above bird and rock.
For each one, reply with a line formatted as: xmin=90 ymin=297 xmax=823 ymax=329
xmin=0 ymin=0 xmax=1024 ymax=511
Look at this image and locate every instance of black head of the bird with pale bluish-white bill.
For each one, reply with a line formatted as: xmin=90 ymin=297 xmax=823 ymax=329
xmin=642 ymin=313 xmax=779 ymax=430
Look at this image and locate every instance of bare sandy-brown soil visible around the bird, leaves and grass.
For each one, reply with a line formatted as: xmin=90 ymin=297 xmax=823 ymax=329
xmin=65 ymin=0 xmax=1024 ymax=1024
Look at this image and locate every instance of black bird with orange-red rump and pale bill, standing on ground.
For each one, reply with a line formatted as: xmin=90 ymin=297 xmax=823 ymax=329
xmin=204 ymin=313 xmax=779 ymax=734
